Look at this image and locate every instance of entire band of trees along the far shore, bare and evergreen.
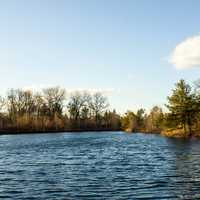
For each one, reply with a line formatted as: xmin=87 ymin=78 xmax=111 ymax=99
xmin=0 ymin=80 xmax=200 ymax=137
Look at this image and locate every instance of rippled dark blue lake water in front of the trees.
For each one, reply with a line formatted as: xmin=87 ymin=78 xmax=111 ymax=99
xmin=0 ymin=132 xmax=200 ymax=200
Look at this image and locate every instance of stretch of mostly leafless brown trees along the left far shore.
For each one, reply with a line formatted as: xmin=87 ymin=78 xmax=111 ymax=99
xmin=0 ymin=87 xmax=120 ymax=132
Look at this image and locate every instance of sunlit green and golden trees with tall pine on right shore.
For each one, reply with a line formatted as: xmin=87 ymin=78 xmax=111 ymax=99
xmin=121 ymin=79 xmax=200 ymax=137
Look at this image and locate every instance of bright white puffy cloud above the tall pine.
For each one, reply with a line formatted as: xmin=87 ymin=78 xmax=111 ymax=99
xmin=170 ymin=35 xmax=200 ymax=69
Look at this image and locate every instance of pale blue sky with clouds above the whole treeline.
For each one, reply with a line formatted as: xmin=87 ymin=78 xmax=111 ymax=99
xmin=0 ymin=0 xmax=200 ymax=112
